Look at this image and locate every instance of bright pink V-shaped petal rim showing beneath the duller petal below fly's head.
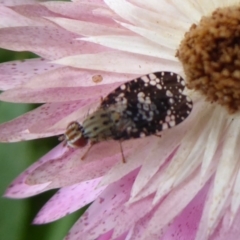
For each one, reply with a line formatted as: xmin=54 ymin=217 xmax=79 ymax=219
xmin=5 ymin=144 xmax=69 ymax=198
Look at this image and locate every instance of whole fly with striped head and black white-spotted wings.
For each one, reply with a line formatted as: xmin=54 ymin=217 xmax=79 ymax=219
xmin=61 ymin=72 xmax=192 ymax=151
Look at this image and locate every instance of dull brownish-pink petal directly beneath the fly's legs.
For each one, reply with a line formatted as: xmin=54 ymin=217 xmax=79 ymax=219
xmin=27 ymin=141 xmax=137 ymax=188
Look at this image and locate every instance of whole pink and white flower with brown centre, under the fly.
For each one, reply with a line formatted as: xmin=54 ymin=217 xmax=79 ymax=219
xmin=0 ymin=0 xmax=240 ymax=240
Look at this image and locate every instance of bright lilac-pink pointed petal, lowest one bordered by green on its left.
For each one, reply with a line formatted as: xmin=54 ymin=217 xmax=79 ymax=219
xmin=34 ymin=178 xmax=106 ymax=224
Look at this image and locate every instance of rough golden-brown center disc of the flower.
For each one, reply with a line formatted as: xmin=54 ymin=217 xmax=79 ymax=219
xmin=176 ymin=7 xmax=240 ymax=113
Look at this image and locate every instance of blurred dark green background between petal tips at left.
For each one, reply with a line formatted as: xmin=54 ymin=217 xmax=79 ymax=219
xmin=0 ymin=49 xmax=82 ymax=240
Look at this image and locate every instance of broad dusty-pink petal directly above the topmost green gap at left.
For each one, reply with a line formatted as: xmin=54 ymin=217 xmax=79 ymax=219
xmin=0 ymin=26 xmax=105 ymax=60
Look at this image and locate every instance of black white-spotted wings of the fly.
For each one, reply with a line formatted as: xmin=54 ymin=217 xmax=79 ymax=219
xmin=100 ymin=72 xmax=192 ymax=140
